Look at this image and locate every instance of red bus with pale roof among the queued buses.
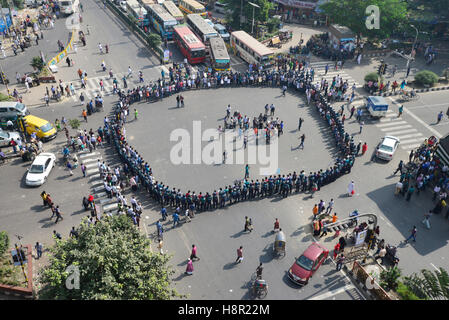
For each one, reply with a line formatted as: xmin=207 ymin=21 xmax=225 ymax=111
xmin=173 ymin=24 xmax=206 ymax=64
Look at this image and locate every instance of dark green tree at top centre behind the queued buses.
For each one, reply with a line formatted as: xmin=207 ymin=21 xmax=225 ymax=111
xmin=220 ymin=0 xmax=274 ymax=31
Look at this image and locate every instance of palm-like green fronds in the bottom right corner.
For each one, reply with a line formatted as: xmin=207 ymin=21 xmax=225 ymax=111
xmin=404 ymin=268 xmax=449 ymax=300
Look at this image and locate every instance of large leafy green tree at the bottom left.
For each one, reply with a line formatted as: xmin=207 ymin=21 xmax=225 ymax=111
xmin=39 ymin=215 xmax=179 ymax=300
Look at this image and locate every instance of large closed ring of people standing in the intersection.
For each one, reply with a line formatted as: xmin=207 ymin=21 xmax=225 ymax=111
xmin=106 ymin=59 xmax=357 ymax=211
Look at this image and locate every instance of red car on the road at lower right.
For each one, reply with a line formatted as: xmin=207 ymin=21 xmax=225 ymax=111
xmin=288 ymin=242 xmax=329 ymax=285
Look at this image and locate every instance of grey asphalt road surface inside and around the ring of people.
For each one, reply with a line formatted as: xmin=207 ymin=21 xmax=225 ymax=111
xmin=0 ymin=1 xmax=448 ymax=299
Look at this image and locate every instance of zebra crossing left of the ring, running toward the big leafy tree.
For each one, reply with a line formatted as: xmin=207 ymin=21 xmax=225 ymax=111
xmin=78 ymin=150 xmax=118 ymax=214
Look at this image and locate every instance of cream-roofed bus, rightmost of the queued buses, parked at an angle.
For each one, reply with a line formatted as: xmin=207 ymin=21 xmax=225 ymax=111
xmin=231 ymin=31 xmax=274 ymax=69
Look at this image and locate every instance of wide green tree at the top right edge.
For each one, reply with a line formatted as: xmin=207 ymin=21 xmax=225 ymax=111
xmin=320 ymin=0 xmax=407 ymax=39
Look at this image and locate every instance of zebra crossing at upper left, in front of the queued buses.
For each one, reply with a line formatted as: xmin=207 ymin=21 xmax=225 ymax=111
xmin=63 ymin=66 xmax=169 ymax=102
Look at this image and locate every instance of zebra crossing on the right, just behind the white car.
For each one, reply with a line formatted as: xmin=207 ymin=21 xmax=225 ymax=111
xmin=376 ymin=110 xmax=426 ymax=151
